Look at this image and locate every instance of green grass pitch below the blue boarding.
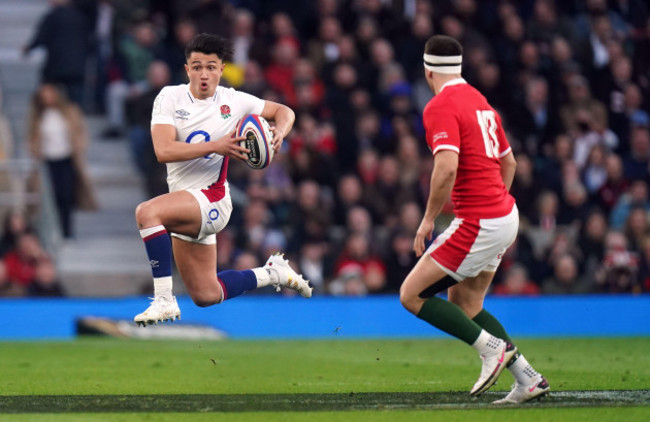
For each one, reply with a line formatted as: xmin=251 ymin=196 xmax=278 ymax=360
xmin=0 ymin=338 xmax=650 ymax=422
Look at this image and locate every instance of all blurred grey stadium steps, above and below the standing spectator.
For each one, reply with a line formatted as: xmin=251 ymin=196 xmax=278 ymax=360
xmin=0 ymin=0 xmax=153 ymax=296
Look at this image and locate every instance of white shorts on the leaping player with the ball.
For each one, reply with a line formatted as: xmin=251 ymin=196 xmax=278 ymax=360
xmin=172 ymin=187 xmax=232 ymax=245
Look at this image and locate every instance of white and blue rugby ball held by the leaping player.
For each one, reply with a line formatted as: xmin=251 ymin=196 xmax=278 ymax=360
xmin=236 ymin=114 xmax=274 ymax=170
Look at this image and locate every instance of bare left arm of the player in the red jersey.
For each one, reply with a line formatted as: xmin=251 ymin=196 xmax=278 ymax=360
xmin=413 ymin=150 xmax=458 ymax=257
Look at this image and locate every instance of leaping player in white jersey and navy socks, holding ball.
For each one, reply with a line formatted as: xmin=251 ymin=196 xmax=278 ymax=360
xmin=134 ymin=34 xmax=311 ymax=325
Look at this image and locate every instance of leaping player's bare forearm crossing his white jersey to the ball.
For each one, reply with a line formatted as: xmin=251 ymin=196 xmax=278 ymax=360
xmin=151 ymin=124 xmax=249 ymax=163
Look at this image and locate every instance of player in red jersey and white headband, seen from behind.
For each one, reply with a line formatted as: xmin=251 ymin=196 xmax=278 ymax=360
xmin=400 ymin=35 xmax=549 ymax=403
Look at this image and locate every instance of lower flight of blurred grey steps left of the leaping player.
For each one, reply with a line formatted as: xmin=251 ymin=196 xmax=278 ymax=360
xmin=58 ymin=117 xmax=151 ymax=296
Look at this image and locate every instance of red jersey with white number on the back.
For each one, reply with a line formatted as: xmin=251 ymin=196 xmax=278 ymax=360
xmin=423 ymin=79 xmax=515 ymax=219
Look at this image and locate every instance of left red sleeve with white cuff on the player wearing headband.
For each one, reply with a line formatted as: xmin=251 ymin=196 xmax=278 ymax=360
xmin=423 ymin=106 xmax=460 ymax=155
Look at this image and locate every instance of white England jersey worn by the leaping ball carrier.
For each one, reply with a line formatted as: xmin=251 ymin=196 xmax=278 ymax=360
xmin=151 ymin=84 xmax=264 ymax=192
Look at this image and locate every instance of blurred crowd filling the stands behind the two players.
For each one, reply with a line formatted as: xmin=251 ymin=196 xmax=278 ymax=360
xmin=3 ymin=0 xmax=650 ymax=295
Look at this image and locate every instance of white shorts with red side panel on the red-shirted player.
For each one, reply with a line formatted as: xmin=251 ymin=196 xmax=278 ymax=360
xmin=426 ymin=205 xmax=519 ymax=281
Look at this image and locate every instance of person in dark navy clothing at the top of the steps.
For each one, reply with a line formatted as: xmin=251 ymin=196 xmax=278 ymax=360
xmin=23 ymin=0 xmax=90 ymax=106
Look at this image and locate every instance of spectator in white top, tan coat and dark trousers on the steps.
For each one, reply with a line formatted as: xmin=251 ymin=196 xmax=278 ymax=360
xmin=28 ymin=84 xmax=97 ymax=238
